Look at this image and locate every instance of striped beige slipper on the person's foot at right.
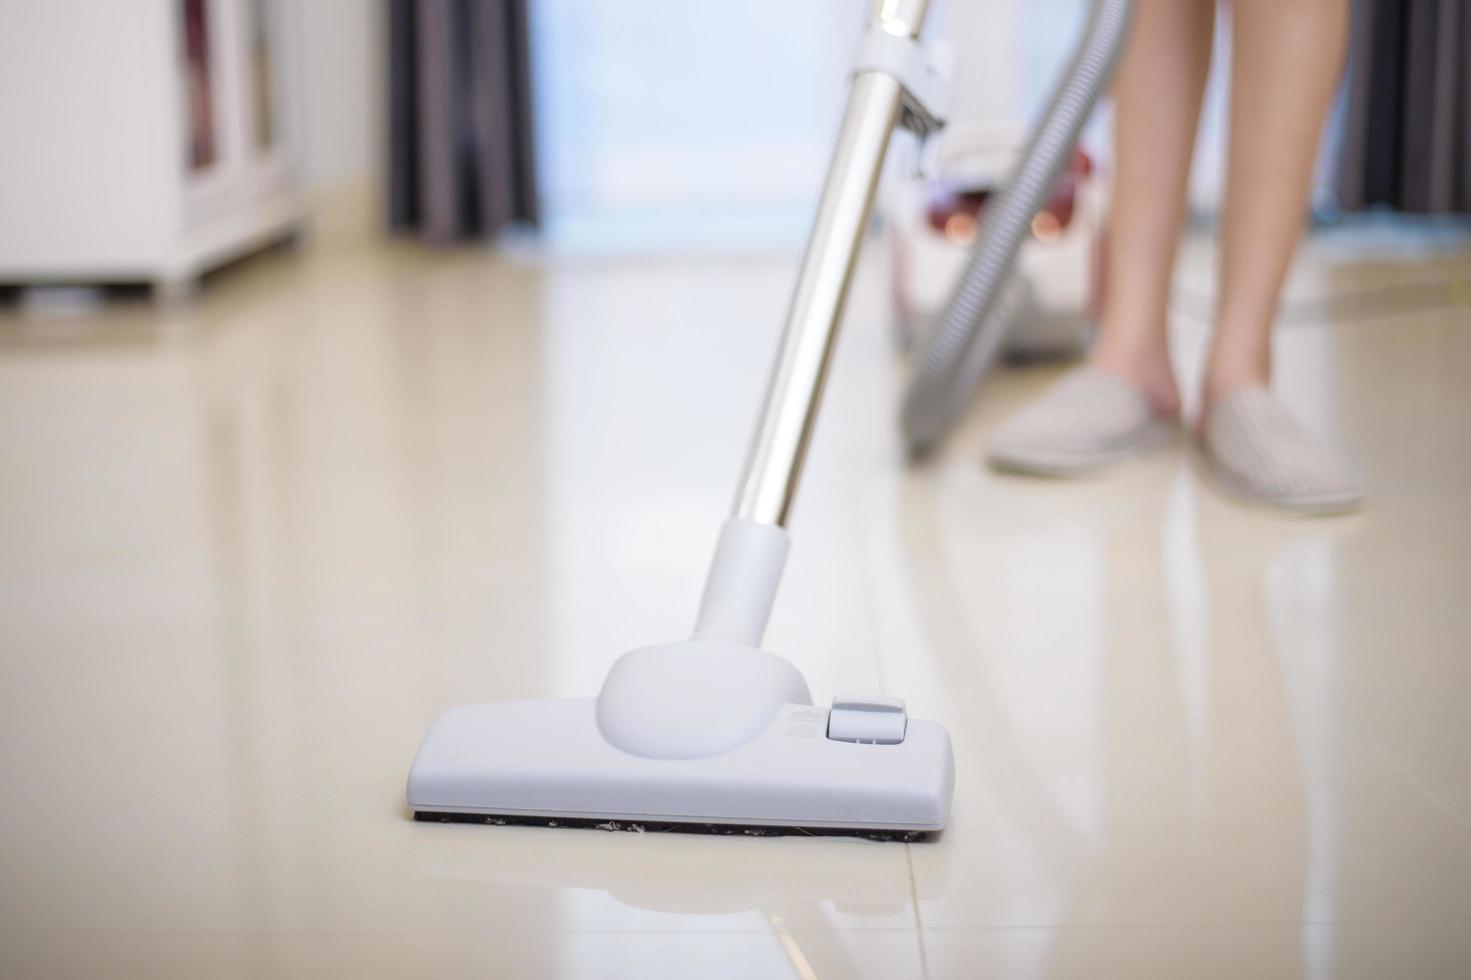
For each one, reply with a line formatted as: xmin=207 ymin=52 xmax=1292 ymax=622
xmin=1200 ymin=386 xmax=1364 ymax=514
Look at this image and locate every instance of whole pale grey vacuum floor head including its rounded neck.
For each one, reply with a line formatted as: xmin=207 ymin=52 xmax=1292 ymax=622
xmin=407 ymin=518 xmax=955 ymax=839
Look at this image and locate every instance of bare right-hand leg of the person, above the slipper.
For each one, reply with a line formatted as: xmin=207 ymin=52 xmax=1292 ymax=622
xmin=1205 ymin=0 xmax=1349 ymax=411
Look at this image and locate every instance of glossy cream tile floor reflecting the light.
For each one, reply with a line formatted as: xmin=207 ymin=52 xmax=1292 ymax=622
xmin=0 ymin=220 xmax=1471 ymax=977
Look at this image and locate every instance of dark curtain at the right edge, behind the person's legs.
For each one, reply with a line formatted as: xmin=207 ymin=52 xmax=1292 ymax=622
xmin=1337 ymin=0 xmax=1471 ymax=213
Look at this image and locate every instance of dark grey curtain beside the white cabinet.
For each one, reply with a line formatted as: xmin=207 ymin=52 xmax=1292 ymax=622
xmin=388 ymin=0 xmax=537 ymax=241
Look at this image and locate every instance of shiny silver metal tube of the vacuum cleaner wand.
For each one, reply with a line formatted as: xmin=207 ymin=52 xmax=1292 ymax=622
xmin=736 ymin=0 xmax=928 ymax=527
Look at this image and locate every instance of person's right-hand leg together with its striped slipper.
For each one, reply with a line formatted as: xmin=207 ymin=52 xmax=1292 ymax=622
xmin=1199 ymin=0 xmax=1364 ymax=514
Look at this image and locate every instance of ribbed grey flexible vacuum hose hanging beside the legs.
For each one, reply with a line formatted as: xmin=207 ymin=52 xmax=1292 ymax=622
xmin=902 ymin=0 xmax=1133 ymax=456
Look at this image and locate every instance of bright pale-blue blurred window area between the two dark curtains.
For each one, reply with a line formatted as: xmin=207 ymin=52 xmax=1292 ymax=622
xmin=533 ymin=0 xmax=1135 ymax=247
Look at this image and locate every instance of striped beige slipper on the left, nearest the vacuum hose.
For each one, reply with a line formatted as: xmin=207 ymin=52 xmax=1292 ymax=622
xmin=986 ymin=366 xmax=1180 ymax=477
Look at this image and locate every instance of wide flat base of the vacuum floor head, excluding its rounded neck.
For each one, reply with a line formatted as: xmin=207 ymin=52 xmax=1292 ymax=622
xmin=407 ymin=697 xmax=955 ymax=840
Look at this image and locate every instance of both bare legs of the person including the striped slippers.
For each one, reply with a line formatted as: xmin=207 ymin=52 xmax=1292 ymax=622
xmin=987 ymin=0 xmax=1364 ymax=503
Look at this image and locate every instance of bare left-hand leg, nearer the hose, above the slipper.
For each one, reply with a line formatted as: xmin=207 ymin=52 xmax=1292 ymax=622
xmin=1091 ymin=0 xmax=1217 ymax=415
